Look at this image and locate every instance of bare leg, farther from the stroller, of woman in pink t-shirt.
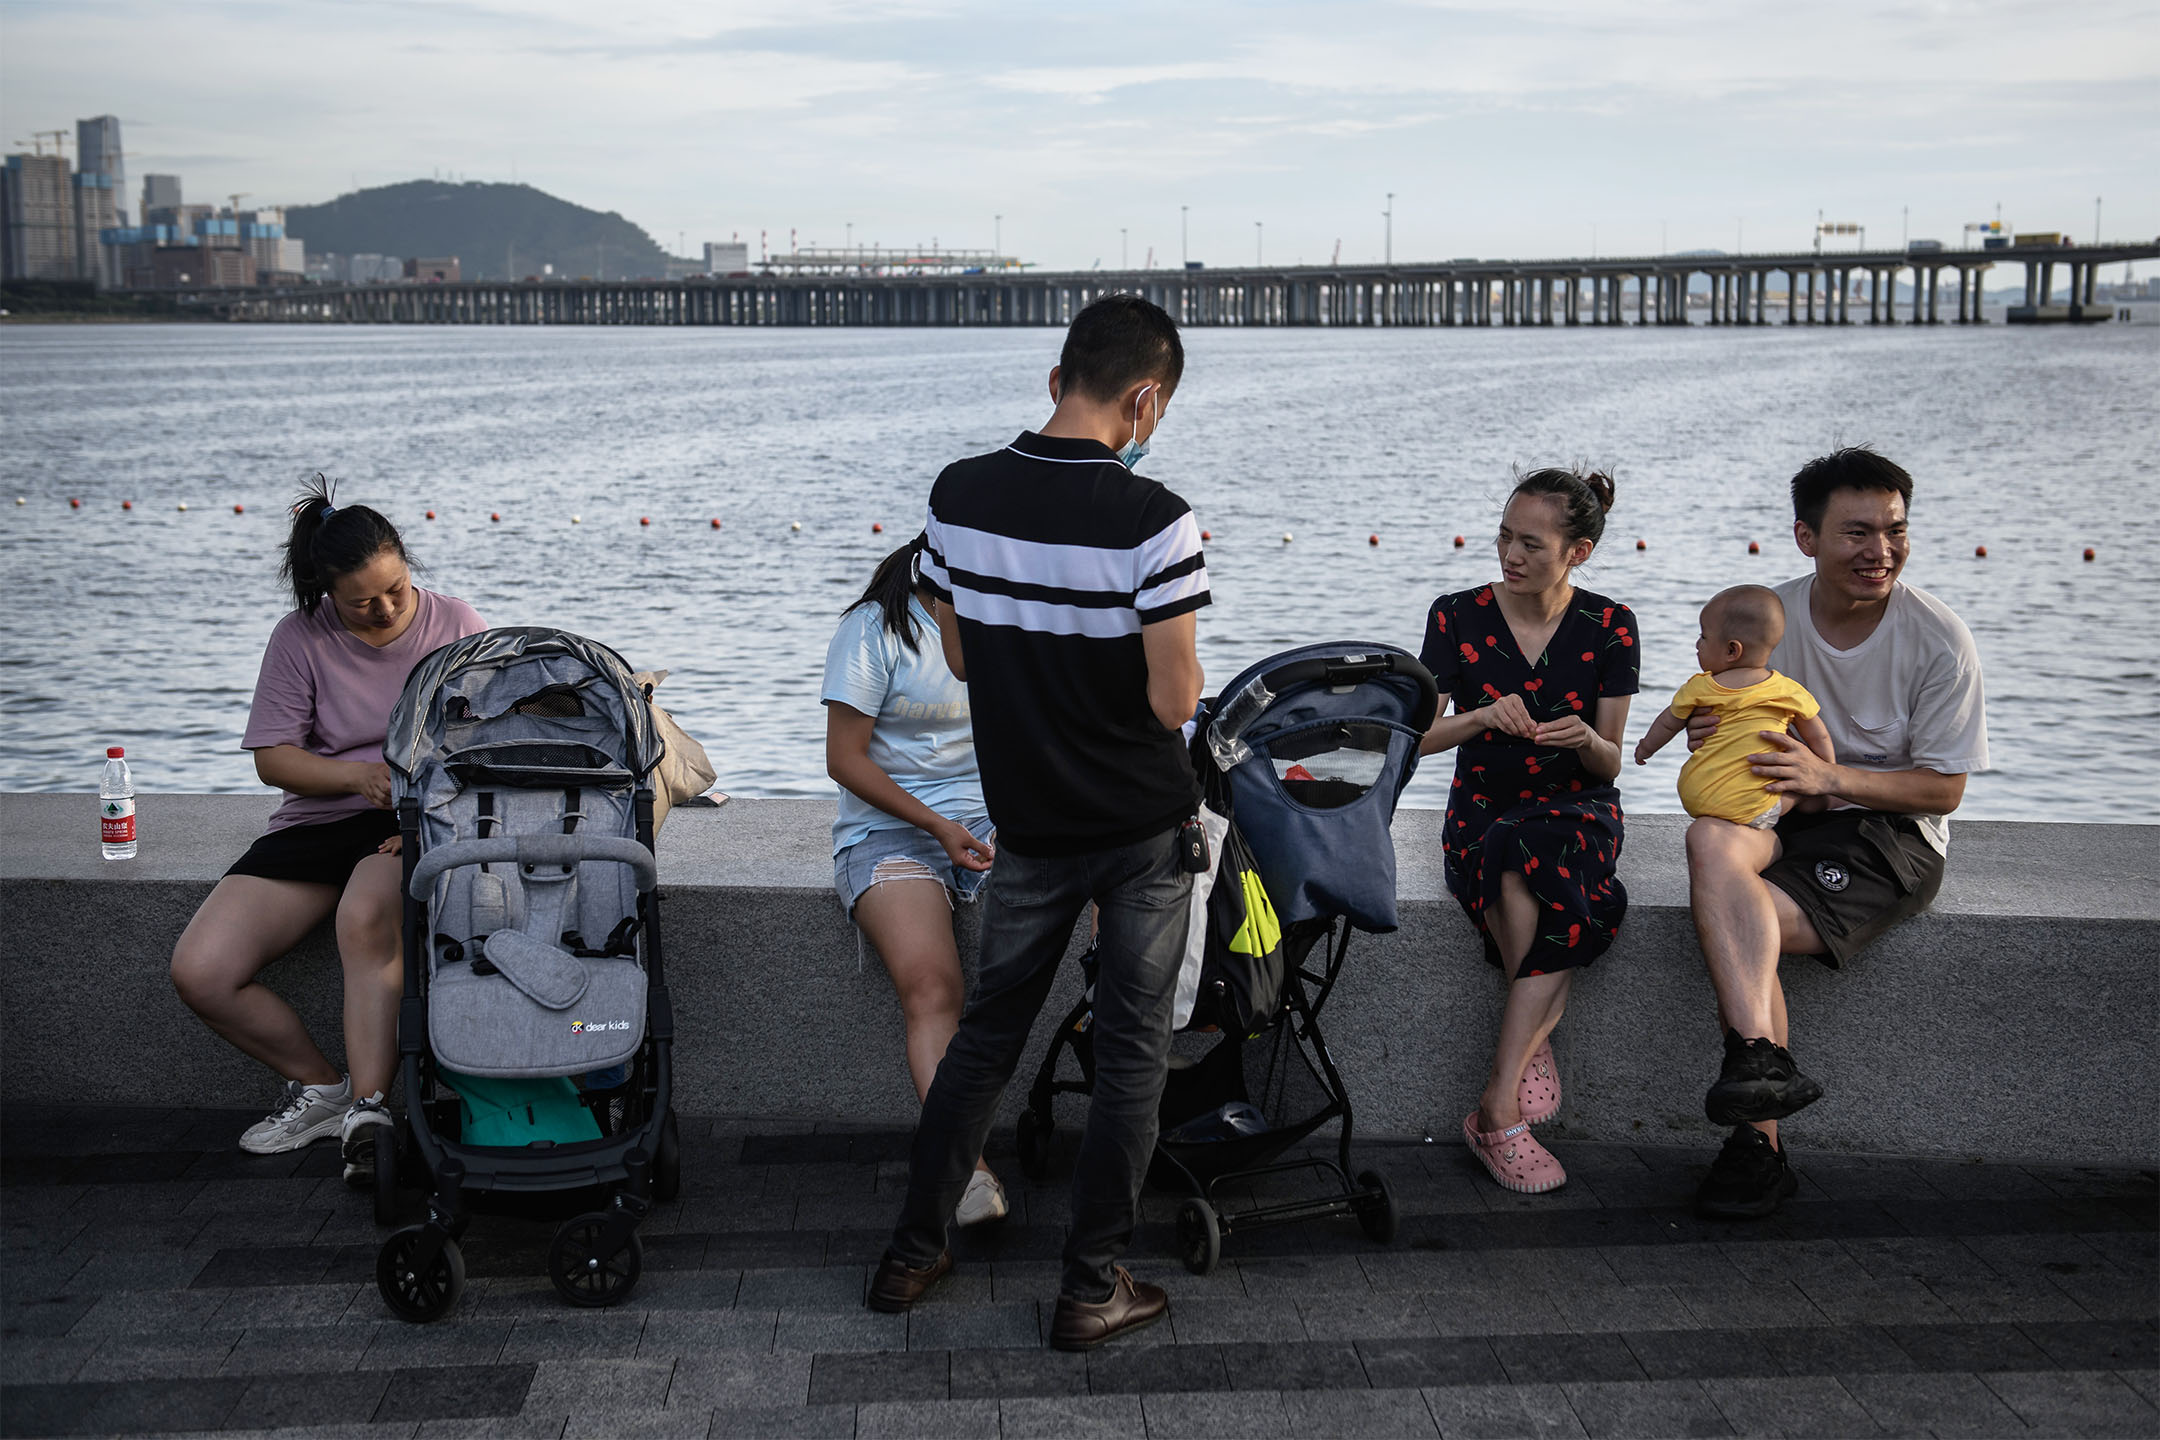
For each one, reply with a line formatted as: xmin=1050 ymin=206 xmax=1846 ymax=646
xmin=173 ymin=874 xmax=341 ymax=1086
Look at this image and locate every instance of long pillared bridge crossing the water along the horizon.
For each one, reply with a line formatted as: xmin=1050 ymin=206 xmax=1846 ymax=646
xmin=210 ymin=240 xmax=2160 ymax=326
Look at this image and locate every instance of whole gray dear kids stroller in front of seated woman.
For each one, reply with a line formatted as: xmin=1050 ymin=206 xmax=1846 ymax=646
xmin=376 ymin=628 xmax=680 ymax=1321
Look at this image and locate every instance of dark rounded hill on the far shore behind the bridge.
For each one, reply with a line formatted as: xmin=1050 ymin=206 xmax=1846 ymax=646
xmin=285 ymin=179 xmax=667 ymax=281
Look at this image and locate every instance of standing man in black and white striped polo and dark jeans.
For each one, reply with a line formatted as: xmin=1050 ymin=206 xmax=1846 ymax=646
xmin=868 ymin=296 xmax=1207 ymax=1349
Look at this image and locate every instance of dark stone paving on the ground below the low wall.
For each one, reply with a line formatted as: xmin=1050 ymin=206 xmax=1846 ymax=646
xmin=0 ymin=1105 xmax=2160 ymax=1440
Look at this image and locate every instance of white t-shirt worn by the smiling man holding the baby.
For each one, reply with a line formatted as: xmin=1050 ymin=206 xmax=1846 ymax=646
xmin=1769 ymin=574 xmax=1987 ymax=853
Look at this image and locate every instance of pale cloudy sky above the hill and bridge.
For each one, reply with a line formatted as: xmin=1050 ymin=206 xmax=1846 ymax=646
xmin=0 ymin=0 xmax=2160 ymax=268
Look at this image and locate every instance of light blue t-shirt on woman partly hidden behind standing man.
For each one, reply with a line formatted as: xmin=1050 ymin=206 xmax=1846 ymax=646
xmin=821 ymin=596 xmax=985 ymax=855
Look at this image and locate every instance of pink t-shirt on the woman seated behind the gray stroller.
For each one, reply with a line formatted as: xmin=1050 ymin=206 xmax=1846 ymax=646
xmin=240 ymin=585 xmax=488 ymax=829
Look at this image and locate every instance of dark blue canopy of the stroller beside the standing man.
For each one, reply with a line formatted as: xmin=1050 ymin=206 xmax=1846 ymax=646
xmin=1205 ymin=641 xmax=1439 ymax=930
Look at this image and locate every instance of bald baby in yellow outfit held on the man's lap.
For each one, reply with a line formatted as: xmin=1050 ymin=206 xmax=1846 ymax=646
xmin=1635 ymin=585 xmax=1836 ymax=829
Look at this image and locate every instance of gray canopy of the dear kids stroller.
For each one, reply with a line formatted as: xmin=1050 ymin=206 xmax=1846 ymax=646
xmin=382 ymin=626 xmax=663 ymax=782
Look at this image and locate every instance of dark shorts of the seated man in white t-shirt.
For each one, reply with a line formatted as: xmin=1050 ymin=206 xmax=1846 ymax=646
xmin=1763 ymin=810 xmax=1942 ymax=969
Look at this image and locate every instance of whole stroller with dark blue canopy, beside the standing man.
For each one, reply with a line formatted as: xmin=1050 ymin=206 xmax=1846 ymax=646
xmin=1015 ymin=643 xmax=1439 ymax=1274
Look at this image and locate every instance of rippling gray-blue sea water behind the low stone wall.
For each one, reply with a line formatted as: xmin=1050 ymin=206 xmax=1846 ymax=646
xmin=0 ymin=324 xmax=2160 ymax=820
